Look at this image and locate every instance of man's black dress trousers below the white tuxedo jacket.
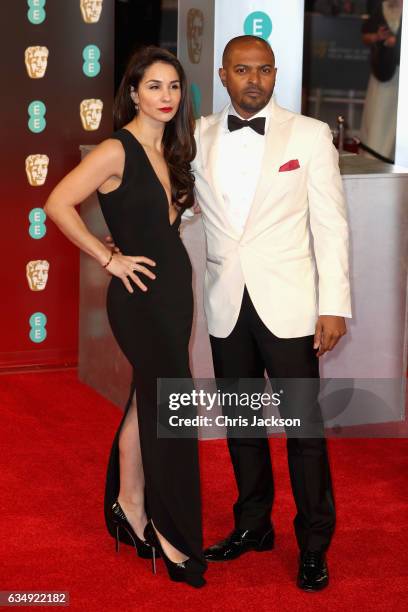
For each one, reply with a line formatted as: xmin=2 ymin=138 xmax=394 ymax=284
xmin=210 ymin=288 xmax=335 ymax=551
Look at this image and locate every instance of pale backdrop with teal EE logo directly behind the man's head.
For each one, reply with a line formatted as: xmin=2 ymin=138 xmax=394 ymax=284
xmin=177 ymin=0 xmax=304 ymax=117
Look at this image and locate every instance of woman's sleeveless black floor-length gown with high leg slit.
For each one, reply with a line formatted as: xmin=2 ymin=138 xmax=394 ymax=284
xmin=98 ymin=129 xmax=205 ymax=570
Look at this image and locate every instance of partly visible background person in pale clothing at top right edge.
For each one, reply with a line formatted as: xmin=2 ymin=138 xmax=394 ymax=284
xmin=360 ymin=0 xmax=403 ymax=163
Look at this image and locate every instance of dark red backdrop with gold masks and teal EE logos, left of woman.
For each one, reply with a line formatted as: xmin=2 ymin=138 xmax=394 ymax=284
xmin=0 ymin=0 xmax=114 ymax=368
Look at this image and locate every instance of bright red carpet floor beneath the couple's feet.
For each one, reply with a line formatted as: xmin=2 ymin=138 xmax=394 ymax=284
xmin=0 ymin=371 xmax=408 ymax=612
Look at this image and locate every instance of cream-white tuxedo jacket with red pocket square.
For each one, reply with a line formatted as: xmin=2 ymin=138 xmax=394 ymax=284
xmin=193 ymin=99 xmax=351 ymax=338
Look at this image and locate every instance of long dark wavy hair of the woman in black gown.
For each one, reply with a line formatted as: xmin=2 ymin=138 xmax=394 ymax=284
xmin=113 ymin=46 xmax=196 ymax=208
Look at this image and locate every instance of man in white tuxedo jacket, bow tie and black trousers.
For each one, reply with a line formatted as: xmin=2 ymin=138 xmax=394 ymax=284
xmin=193 ymin=36 xmax=351 ymax=590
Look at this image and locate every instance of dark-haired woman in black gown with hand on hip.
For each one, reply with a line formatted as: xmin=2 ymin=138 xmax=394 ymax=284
xmin=45 ymin=47 xmax=206 ymax=587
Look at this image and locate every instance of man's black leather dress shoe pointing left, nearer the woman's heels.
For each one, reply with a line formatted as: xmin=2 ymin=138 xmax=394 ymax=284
xmin=204 ymin=527 xmax=274 ymax=561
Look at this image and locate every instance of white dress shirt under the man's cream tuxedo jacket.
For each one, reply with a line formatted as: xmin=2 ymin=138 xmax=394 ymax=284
xmin=216 ymin=104 xmax=268 ymax=235
